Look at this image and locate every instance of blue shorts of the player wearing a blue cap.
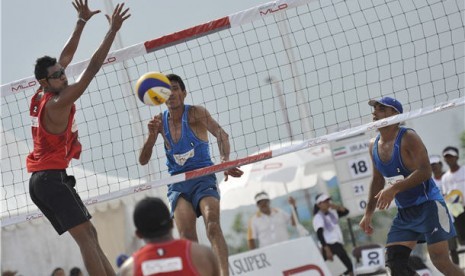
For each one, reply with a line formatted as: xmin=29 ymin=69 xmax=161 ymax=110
xmin=387 ymin=200 xmax=456 ymax=244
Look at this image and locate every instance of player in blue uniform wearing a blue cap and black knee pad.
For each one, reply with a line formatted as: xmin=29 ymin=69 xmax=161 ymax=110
xmin=360 ymin=97 xmax=465 ymax=276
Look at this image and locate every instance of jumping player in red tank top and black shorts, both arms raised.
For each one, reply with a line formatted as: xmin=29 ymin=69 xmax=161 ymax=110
xmin=26 ymin=0 xmax=130 ymax=276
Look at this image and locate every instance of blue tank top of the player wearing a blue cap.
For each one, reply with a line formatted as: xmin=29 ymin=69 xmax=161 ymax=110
xmin=373 ymin=127 xmax=444 ymax=208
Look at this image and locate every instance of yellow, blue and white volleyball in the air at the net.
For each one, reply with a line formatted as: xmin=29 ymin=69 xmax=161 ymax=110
xmin=136 ymin=72 xmax=171 ymax=105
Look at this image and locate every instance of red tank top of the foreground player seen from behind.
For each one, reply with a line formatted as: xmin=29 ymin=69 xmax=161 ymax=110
xmin=132 ymin=240 xmax=200 ymax=276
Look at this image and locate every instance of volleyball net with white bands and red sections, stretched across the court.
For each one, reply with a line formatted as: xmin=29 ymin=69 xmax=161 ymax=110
xmin=1 ymin=0 xmax=465 ymax=226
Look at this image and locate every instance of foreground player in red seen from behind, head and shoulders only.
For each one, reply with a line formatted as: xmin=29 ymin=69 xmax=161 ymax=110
xmin=118 ymin=197 xmax=220 ymax=276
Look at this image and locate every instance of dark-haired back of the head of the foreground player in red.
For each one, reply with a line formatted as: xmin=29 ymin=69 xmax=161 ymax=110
xmin=133 ymin=197 xmax=173 ymax=239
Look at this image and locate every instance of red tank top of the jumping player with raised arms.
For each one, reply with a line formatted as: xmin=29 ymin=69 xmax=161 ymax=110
xmin=26 ymin=89 xmax=82 ymax=172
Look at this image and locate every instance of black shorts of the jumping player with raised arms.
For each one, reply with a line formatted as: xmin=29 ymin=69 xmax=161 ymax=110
xmin=29 ymin=170 xmax=91 ymax=235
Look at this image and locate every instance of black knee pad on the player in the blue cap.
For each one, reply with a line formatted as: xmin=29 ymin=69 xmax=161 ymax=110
xmin=386 ymin=245 xmax=416 ymax=276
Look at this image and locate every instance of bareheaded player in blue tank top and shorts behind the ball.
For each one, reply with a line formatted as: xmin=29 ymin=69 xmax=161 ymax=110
xmin=139 ymin=74 xmax=243 ymax=275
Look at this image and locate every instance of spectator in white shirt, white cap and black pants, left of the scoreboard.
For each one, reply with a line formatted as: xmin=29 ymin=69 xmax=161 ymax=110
xmin=313 ymin=194 xmax=354 ymax=275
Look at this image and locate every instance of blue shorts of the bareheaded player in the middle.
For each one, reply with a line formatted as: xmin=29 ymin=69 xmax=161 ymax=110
xmin=167 ymin=174 xmax=220 ymax=217
